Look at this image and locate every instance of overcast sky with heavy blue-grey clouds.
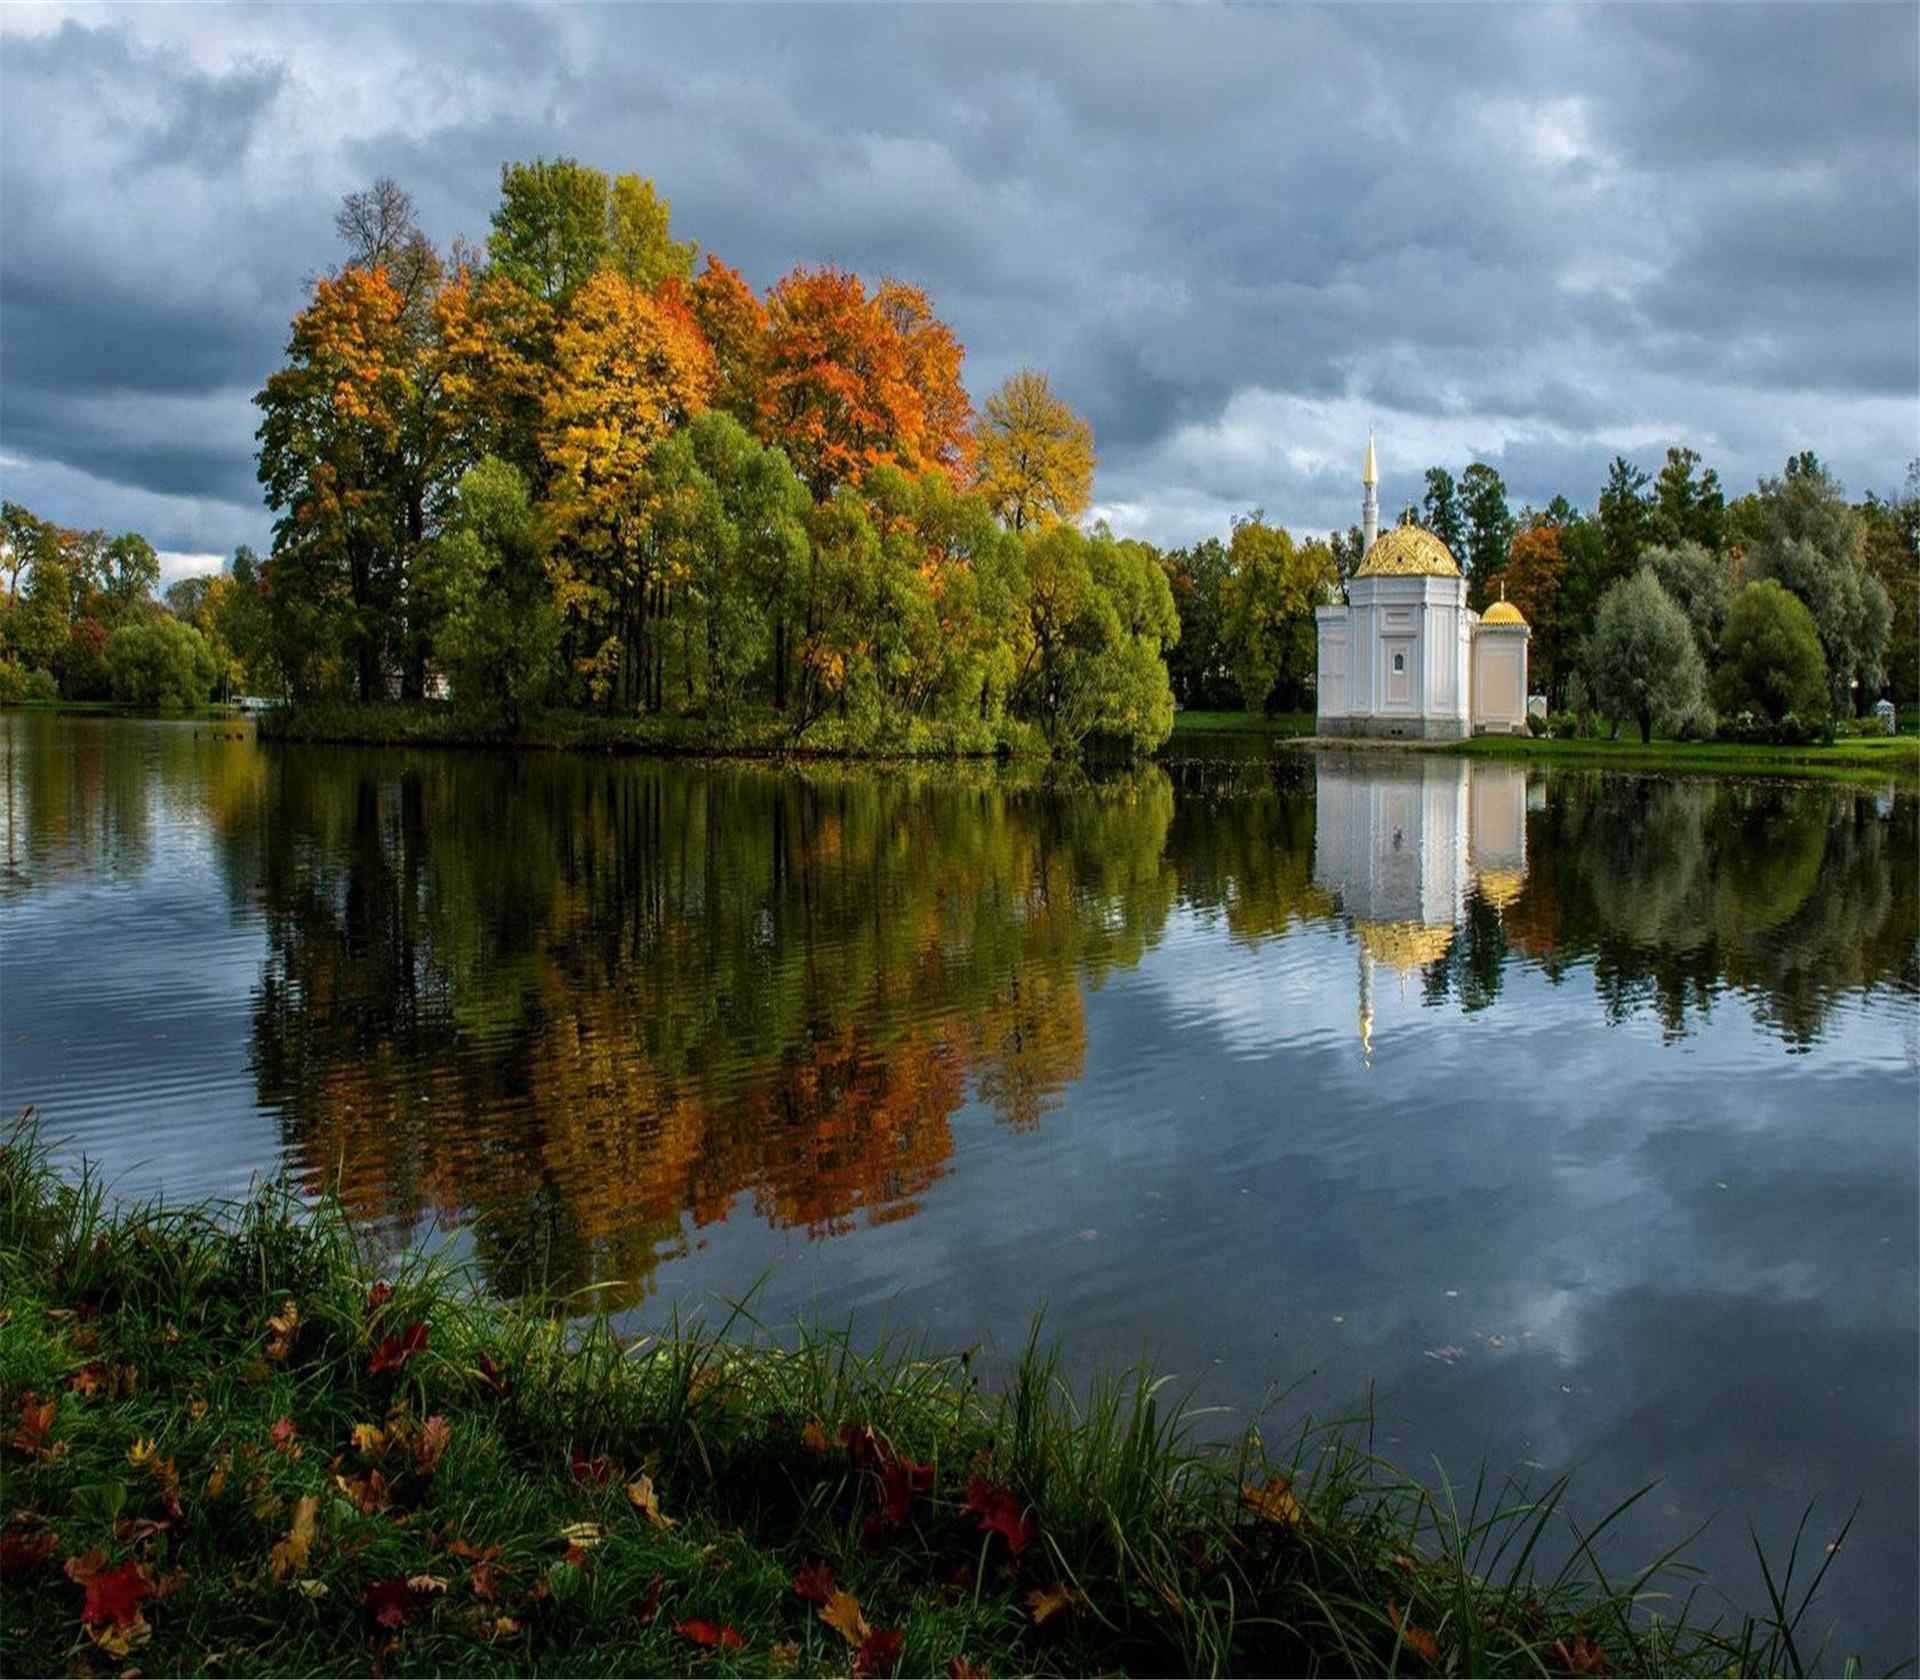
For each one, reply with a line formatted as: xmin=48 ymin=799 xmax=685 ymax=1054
xmin=0 ymin=4 xmax=1920 ymax=576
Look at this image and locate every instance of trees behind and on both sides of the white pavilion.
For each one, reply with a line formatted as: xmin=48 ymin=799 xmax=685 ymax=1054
xmin=1164 ymin=447 xmax=1920 ymax=732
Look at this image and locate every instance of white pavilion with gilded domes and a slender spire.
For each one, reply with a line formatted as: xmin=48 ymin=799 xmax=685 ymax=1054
xmin=1313 ymin=436 xmax=1532 ymax=741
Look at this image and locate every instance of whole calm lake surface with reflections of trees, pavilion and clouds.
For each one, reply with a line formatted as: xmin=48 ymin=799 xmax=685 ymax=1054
xmin=0 ymin=712 xmax=1920 ymax=1667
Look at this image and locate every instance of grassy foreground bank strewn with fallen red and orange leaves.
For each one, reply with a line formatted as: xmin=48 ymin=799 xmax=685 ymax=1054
xmin=0 ymin=1127 xmax=1881 ymax=1674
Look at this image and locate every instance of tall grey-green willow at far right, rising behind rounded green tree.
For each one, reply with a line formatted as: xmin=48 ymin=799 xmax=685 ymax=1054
xmin=1747 ymin=451 xmax=1893 ymax=716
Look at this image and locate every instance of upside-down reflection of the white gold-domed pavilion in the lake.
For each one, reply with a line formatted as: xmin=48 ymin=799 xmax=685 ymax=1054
xmin=1313 ymin=755 xmax=1526 ymax=1060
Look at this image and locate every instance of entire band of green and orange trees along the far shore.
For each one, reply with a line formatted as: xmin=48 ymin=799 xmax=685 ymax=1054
xmin=0 ymin=157 xmax=1920 ymax=737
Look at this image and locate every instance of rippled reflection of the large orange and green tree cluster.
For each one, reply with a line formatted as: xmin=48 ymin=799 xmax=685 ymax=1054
xmin=236 ymin=753 xmax=1173 ymax=1288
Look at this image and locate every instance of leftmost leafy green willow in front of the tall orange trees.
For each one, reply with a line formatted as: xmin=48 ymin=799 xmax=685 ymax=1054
xmin=432 ymin=455 xmax=561 ymax=730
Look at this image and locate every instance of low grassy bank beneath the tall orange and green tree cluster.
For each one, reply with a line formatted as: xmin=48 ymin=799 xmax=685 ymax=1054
xmin=259 ymin=701 xmax=1048 ymax=758
